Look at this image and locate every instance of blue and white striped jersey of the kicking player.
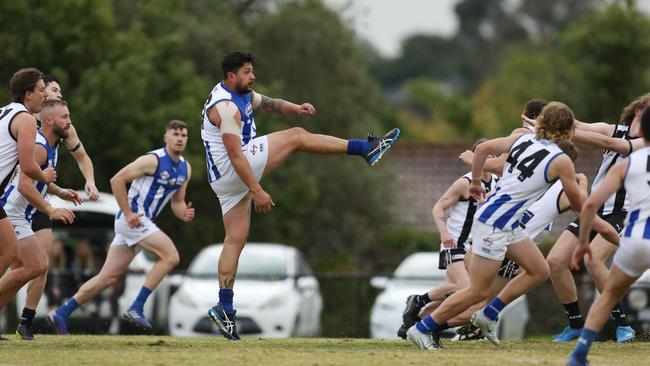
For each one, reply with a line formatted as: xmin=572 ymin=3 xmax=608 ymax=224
xmin=201 ymin=83 xmax=257 ymax=183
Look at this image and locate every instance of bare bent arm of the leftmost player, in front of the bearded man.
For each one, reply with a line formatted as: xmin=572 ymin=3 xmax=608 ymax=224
xmin=11 ymin=113 xmax=56 ymax=183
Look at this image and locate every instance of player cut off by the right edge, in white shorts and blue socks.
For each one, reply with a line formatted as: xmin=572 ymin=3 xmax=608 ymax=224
xmin=567 ymin=108 xmax=650 ymax=366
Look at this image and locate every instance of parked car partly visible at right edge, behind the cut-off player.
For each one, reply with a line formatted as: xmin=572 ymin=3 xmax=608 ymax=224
xmin=623 ymin=270 xmax=650 ymax=333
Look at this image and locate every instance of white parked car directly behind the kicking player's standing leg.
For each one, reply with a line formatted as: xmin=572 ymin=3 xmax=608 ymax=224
xmin=169 ymin=243 xmax=323 ymax=338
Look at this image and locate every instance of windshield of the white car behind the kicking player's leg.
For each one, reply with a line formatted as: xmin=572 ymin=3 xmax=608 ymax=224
xmin=188 ymin=246 xmax=287 ymax=281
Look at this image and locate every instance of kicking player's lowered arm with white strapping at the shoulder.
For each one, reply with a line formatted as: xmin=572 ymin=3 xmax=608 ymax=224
xmin=208 ymin=101 xmax=275 ymax=213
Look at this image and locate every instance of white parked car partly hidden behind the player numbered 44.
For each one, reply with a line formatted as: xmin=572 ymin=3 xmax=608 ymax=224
xmin=370 ymin=252 xmax=529 ymax=339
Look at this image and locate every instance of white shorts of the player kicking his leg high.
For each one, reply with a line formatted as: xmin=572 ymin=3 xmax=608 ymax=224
xmin=210 ymin=136 xmax=269 ymax=215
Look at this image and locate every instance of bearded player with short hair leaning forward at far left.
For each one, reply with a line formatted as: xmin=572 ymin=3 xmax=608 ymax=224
xmin=0 ymin=101 xmax=81 ymax=309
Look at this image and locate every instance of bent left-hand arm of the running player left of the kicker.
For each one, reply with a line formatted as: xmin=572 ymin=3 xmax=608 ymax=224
xmin=111 ymin=154 xmax=158 ymax=228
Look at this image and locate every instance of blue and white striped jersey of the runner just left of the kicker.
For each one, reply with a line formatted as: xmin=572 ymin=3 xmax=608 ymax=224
xmin=117 ymin=147 xmax=188 ymax=220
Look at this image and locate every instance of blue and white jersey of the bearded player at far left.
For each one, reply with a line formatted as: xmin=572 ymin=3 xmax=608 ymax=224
xmin=0 ymin=131 xmax=59 ymax=222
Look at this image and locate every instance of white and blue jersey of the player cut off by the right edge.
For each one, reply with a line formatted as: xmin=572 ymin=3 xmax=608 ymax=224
xmin=623 ymin=147 xmax=650 ymax=239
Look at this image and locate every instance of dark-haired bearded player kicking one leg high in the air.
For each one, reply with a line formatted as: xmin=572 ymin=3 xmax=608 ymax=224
xmin=201 ymin=52 xmax=399 ymax=340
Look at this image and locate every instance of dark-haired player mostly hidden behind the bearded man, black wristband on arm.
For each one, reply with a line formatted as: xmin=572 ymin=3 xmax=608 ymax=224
xmin=16 ymin=75 xmax=99 ymax=340
